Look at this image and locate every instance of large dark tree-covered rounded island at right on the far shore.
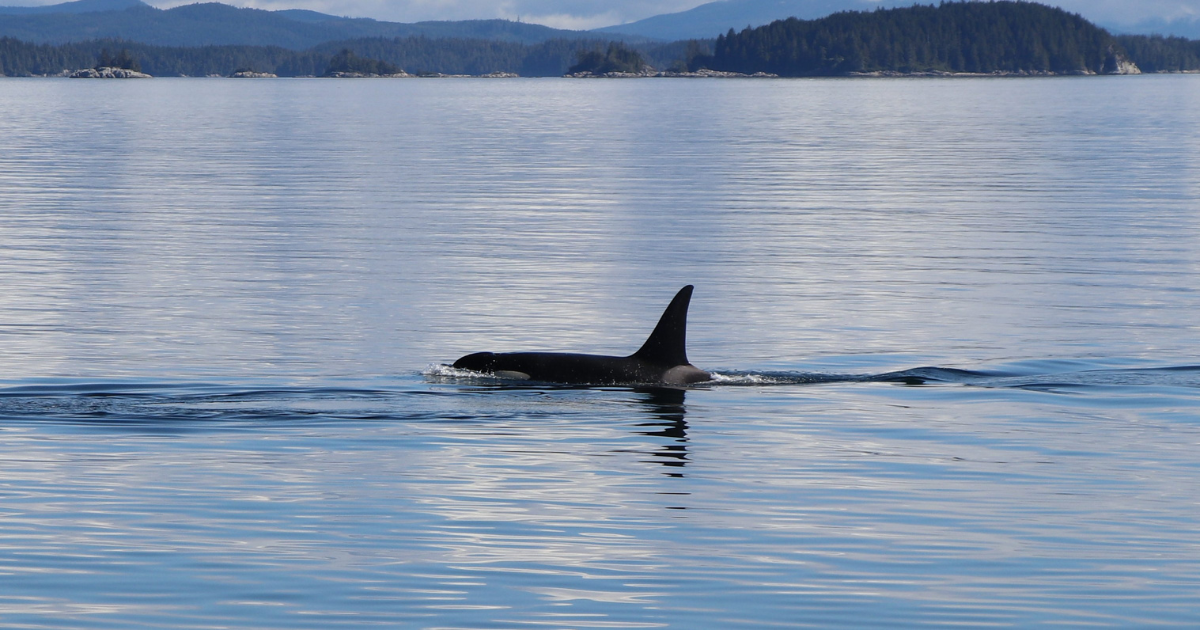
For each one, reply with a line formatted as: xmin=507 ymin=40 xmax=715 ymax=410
xmin=689 ymin=1 xmax=1138 ymax=77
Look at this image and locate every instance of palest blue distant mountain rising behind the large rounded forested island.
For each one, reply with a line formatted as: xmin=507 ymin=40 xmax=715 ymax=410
xmin=593 ymin=0 xmax=1200 ymax=41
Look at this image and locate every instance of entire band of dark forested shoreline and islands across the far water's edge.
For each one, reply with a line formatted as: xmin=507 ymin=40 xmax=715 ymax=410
xmin=0 ymin=1 xmax=1200 ymax=77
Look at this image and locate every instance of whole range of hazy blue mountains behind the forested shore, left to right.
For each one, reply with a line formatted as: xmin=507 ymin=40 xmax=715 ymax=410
xmin=0 ymin=0 xmax=1200 ymax=50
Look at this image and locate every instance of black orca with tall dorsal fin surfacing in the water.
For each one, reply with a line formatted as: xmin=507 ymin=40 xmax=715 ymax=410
xmin=454 ymin=284 xmax=713 ymax=385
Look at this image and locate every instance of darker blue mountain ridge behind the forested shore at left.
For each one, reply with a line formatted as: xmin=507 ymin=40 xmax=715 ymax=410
xmin=0 ymin=0 xmax=619 ymax=50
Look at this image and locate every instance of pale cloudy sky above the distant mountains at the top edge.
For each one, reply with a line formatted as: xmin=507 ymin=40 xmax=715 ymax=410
xmin=37 ymin=0 xmax=1200 ymax=29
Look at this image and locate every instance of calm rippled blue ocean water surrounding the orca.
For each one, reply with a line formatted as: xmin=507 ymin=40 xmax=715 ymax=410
xmin=0 ymin=76 xmax=1200 ymax=629
